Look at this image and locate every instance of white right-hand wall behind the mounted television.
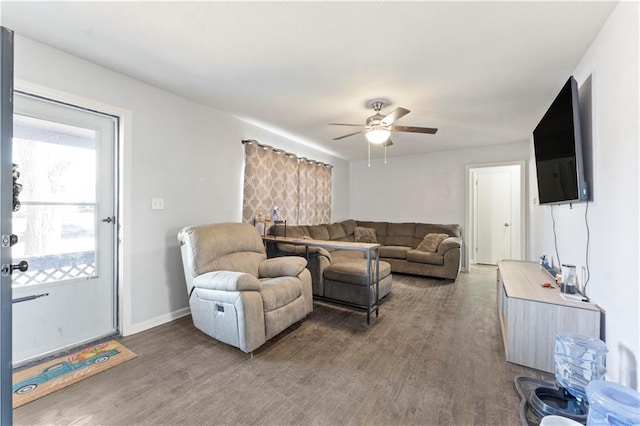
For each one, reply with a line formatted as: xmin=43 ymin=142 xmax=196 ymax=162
xmin=531 ymin=2 xmax=640 ymax=389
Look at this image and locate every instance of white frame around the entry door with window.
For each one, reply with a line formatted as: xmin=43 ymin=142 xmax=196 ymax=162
xmin=15 ymin=80 xmax=133 ymax=336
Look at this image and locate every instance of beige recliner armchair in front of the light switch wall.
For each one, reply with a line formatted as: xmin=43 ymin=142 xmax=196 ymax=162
xmin=178 ymin=223 xmax=313 ymax=352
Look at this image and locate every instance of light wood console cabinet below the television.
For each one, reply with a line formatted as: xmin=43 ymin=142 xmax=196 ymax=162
xmin=497 ymin=260 xmax=604 ymax=373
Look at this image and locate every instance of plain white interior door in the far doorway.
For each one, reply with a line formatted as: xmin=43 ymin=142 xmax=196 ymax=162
xmin=476 ymin=171 xmax=512 ymax=265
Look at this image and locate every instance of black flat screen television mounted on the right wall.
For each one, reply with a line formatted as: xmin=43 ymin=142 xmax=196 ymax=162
xmin=533 ymin=76 xmax=589 ymax=204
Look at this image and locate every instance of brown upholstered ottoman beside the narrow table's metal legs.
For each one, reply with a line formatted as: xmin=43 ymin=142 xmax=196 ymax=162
xmin=324 ymin=259 xmax=392 ymax=306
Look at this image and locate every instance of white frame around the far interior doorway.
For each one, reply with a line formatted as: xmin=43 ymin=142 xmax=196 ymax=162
xmin=462 ymin=160 xmax=528 ymax=271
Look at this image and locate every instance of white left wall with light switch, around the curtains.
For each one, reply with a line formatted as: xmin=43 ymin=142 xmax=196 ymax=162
xmin=15 ymin=35 xmax=349 ymax=333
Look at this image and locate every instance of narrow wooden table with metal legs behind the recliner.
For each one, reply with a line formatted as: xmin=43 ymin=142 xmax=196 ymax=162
xmin=262 ymin=235 xmax=380 ymax=324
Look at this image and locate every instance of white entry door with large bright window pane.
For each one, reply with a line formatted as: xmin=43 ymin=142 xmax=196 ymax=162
xmin=12 ymin=94 xmax=117 ymax=365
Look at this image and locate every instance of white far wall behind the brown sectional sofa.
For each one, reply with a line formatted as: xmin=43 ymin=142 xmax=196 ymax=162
xmin=350 ymin=142 xmax=529 ymax=227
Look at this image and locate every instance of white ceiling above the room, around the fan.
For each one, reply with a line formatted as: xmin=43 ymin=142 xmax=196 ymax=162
xmin=1 ymin=1 xmax=616 ymax=160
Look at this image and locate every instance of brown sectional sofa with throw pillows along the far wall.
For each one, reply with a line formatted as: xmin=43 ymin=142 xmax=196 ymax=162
xmin=267 ymin=219 xmax=462 ymax=303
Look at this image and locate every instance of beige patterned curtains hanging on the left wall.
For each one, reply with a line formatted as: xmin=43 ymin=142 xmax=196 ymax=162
xmin=242 ymin=140 xmax=331 ymax=225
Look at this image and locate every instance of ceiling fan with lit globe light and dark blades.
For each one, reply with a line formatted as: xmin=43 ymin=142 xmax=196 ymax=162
xmin=329 ymin=99 xmax=438 ymax=147
